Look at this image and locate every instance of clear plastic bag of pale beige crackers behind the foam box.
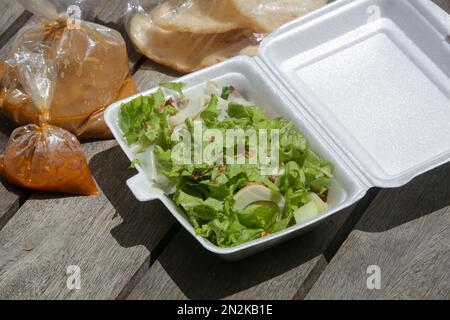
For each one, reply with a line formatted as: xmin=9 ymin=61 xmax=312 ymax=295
xmin=128 ymin=0 xmax=327 ymax=73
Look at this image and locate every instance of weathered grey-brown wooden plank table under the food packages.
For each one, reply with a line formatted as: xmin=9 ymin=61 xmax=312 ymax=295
xmin=0 ymin=0 xmax=450 ymax=299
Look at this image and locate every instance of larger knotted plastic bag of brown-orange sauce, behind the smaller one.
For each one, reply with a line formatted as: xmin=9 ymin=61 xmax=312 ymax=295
xmin=0 ymin=0 xmax=136 ymax=139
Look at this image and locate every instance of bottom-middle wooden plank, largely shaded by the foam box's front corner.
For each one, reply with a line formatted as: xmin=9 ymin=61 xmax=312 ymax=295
xmin=128 ymin=209 xmax=351 ymax=299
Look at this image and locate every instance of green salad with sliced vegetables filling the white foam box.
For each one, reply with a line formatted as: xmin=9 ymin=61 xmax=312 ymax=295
xmin=120 ymin=82 xmax=333 ymax=247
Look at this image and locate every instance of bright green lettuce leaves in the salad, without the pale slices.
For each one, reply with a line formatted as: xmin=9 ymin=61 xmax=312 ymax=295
xmin=120 ymin=83 xmax=334 ymax=247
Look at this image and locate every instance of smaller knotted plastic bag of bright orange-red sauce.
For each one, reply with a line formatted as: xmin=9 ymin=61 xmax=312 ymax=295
xmin=0 ymin=124 xmax=97 ymax=195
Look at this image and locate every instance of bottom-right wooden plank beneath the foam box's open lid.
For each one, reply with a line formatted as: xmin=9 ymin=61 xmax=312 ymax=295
xmin=307 ymin=164 xmax=450 ymax=299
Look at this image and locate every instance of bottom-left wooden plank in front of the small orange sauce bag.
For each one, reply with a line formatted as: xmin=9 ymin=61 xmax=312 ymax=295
xmin=0 ymin=141 xmax=172 ymax=299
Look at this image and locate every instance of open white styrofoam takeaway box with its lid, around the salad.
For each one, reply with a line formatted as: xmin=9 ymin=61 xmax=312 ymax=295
xmin=105 ymin=0 xmax=450 ymax=260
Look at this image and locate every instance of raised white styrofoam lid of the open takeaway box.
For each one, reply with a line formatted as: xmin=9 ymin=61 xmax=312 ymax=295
xmin=258 ymin=0 xmax=450 ymax=187
